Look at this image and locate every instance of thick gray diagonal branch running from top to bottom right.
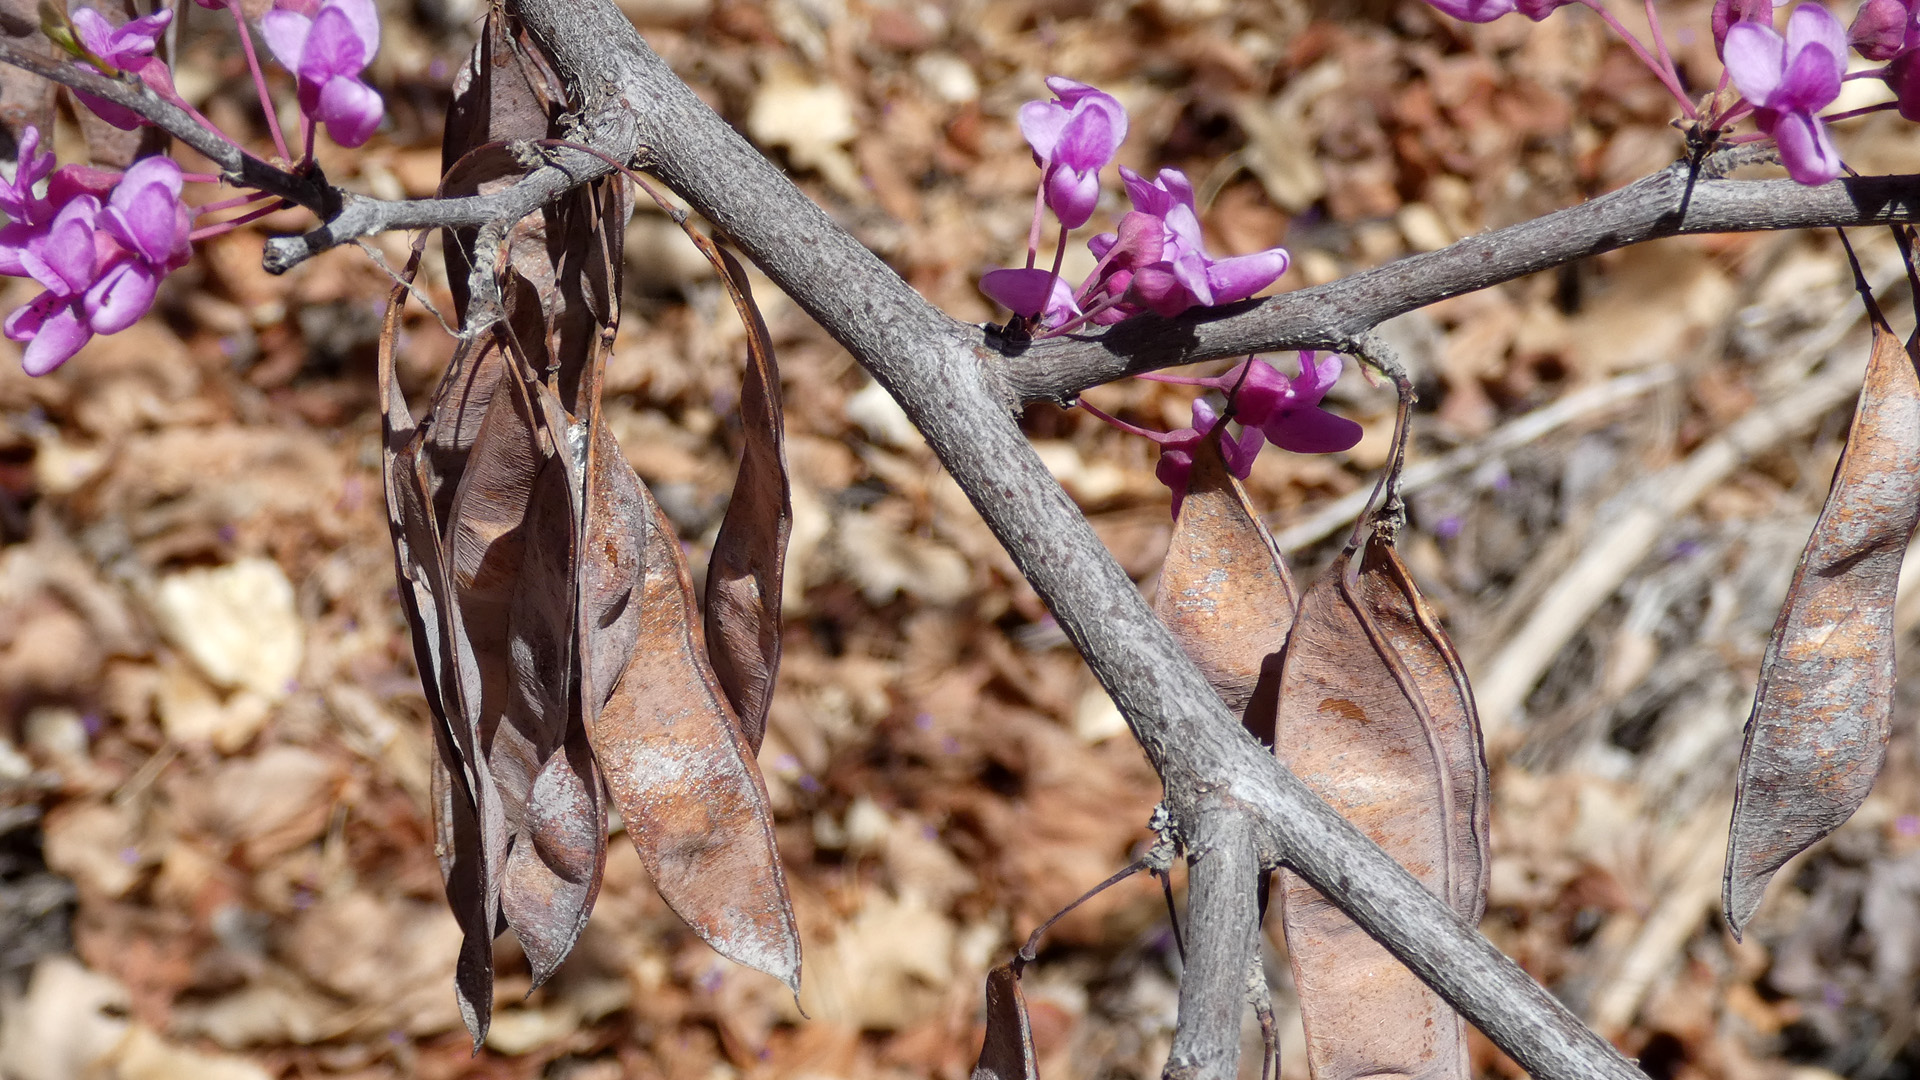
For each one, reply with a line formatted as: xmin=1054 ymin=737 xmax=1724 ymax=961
xmin=511 ymin=0 xmax=1640 ymax=1080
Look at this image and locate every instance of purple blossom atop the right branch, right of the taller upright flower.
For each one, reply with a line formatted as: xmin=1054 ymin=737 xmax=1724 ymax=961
xmin=1079 ymin=165 xmax=1288 ymax=323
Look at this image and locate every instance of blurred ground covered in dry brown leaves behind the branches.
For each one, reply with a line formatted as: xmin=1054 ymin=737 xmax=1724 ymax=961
xmin=0 ymin=0 xmax=1920 ymax=1080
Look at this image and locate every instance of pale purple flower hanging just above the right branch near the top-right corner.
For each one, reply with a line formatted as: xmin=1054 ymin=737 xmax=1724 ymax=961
xmin=1726 ymin=4 xmax=1847 ymax=184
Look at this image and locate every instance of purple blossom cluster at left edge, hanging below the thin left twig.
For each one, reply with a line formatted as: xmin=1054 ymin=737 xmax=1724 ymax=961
xmin=0 ymin=158 xmax=192 ymax=375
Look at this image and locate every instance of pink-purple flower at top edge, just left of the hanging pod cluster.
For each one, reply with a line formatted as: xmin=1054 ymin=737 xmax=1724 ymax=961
xmin=259 ymin=0 xmax=386 ymax=146
